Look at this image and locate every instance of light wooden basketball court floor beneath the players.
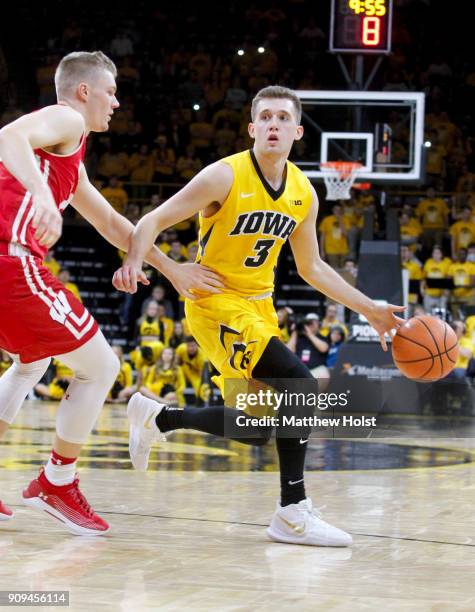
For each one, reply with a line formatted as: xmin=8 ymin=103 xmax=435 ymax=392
xmin=0 ymin=401 xmax=475 ymax=612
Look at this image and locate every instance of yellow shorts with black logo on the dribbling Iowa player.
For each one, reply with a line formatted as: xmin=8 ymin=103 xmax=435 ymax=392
xmin=185 ymin=294 xmax=280 ymax=393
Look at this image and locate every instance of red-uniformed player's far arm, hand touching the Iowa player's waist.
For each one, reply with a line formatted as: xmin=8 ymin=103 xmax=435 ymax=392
xmin=72 ymin=165 xmax=229 ymax=298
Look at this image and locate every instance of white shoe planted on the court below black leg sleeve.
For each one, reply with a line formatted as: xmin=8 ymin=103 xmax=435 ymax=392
xmin=267 ymin=497 xmax=353 ymax=546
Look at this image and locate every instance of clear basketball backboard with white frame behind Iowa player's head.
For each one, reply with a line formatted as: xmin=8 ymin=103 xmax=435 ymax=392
xmin=293 ymin=90 xmax=425 ymax=183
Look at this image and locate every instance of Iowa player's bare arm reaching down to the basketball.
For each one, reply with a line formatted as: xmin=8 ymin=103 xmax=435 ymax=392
xmin=290 ymin=186 xmax=404 ymax=351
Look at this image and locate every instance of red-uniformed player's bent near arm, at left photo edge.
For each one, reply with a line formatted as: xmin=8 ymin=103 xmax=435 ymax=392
xmin=0 ymin=105 xmax=84 ymax=248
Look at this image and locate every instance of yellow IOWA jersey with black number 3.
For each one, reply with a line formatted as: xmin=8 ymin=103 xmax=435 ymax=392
xmin=197 ymin=150 xmax=312 ymax=296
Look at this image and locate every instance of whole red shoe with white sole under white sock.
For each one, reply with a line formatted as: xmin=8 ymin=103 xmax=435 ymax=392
xmin=23 ymin=468 xmax=109 ymax=535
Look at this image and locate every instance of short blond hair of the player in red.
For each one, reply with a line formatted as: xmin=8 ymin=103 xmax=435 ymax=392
xmin=54 ymin=51 xmax=117 ymax=98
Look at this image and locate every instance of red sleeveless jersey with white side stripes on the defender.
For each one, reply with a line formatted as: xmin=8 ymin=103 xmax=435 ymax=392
xmin=0 ymin=135 xmax=86 ymax=259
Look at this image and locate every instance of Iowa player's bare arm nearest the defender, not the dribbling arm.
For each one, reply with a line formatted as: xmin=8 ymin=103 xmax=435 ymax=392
xmin=113 ymin=162 xmax=233 ymax=299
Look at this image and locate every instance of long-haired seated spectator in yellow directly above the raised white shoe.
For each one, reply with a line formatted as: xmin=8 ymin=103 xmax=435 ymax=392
xmin=140 ymin=347 xmax=186 ymax=408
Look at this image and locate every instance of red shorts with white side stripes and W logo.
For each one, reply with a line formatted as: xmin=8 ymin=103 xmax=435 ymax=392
xmin=0 ymin=255 xmax=99 ymax=363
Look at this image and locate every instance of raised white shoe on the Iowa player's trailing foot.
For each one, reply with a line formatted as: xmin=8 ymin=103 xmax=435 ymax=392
xmin=127 ymin=393 xmax=166 ymax=470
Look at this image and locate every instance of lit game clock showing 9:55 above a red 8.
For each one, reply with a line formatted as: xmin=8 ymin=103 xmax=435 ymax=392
xmin=330 ymin=0 xmax=393 ymax=53
